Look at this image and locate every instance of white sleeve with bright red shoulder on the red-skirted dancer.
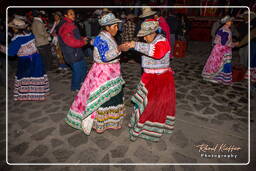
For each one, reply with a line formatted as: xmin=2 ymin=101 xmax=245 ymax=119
xmin=134 ymin=41 xmax=170 ymax=59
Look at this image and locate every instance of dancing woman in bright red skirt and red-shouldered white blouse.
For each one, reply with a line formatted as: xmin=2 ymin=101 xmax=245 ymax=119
xmin=124 ymin=19 xmax=176 ymax=141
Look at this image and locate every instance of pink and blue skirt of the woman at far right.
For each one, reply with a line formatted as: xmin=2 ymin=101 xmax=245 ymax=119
xmin=202 ymin=44 xmax=232 ymax=85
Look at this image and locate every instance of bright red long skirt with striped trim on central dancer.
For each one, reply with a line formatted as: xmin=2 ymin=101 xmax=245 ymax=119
xmin=129 ymin=70 xmax=176 ymax=141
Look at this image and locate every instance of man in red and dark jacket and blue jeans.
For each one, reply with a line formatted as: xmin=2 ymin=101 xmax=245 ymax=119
xmin=58 ymin=9 xmax=88 ymax=91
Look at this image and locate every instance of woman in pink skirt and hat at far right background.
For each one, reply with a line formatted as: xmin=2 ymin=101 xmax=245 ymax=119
xmin=202 ymin=16 xmax=238 ymax=85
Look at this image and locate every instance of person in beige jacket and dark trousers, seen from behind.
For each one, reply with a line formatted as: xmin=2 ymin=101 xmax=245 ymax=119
xmin=32 ymin=10 xmax=53 ymax=72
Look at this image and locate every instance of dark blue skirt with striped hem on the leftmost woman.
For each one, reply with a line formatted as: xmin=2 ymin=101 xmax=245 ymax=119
xmin=14 ymin=53 xmax=49 ymax=101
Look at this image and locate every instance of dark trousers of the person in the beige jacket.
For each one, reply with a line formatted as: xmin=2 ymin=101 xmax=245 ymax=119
xmin=37 ymin=44 xmax=53 ymax=72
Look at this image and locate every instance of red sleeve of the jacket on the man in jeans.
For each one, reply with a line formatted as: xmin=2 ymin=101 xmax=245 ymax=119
xmin=59 ymin=23 xmax=85 ymax=48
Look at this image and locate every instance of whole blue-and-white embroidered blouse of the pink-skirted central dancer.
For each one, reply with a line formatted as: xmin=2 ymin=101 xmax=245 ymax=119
xmin=93 ymin=31 xmax=121 ymax=63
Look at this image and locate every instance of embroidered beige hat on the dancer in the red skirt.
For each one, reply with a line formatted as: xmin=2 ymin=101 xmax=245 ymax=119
xmin=137 ymin=19 xmax=159 ymax=37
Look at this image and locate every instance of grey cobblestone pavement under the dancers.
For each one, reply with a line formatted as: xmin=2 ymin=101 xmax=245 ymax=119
xmin=0 ymin=42 xmax=256 ymax=171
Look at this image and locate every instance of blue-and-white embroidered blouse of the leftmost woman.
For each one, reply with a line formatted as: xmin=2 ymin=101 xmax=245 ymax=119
xmin=8 ymin=33 xmax=37 ymax=57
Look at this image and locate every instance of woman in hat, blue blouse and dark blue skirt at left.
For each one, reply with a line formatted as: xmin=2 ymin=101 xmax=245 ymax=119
xmin=8 ymin=18 xmax=49 ymax=100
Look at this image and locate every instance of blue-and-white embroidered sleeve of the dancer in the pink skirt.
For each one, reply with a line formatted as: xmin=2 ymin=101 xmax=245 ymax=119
xmin=93 ymin=36 xmax=121 ymax=62
